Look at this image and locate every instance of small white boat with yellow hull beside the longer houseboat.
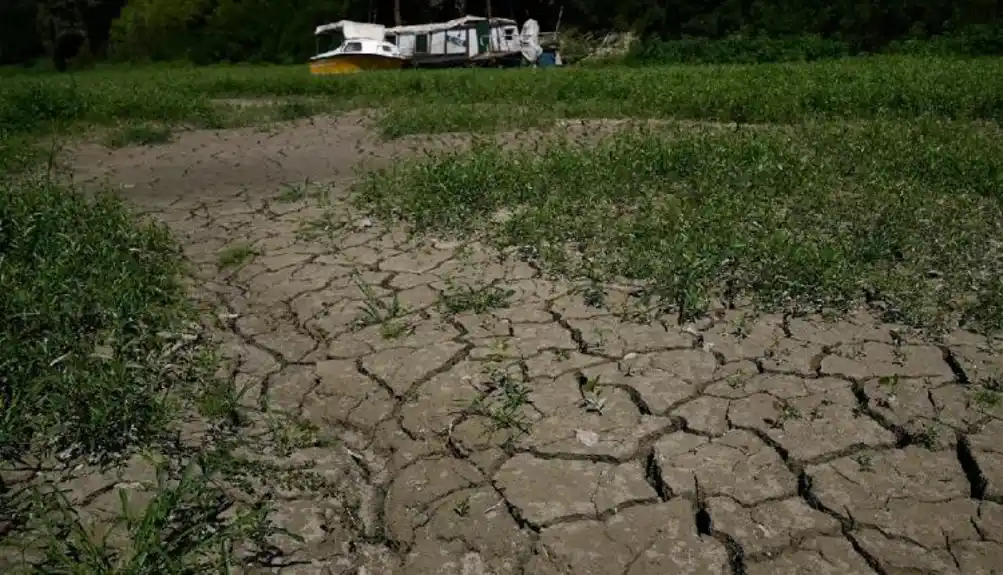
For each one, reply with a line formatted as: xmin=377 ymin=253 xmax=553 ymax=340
xmin=310 ymin=20 xmax=407 ymax=75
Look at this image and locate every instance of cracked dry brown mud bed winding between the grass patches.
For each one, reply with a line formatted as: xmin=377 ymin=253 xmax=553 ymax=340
xmin=64 ymin=117 xmax=1003 ymax=575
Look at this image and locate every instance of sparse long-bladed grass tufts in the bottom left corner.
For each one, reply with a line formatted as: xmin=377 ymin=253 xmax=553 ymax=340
xmin=24 ymin=455 xmax=276 ymax=575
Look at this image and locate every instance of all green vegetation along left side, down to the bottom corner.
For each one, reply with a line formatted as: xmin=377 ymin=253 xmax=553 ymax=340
xmin=0 ymin=174 xmax=282 ymax=574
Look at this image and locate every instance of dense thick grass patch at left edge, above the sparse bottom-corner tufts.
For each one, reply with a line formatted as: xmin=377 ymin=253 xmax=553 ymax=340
xmin=0 ymin=172 xmax=202 ymax=461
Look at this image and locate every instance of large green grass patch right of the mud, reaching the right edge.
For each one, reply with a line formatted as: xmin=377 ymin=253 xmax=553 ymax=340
xmin=357 ymin=120 xmax=1003 ymax=330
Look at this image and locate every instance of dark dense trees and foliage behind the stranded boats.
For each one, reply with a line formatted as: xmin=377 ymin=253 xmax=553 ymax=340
xmin=0 ymin=0 xmax=1003 ymax=68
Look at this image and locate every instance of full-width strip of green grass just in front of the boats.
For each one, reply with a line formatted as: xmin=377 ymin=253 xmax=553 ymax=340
xmin=0 ymin=56 xmax=1003 ymax=139
